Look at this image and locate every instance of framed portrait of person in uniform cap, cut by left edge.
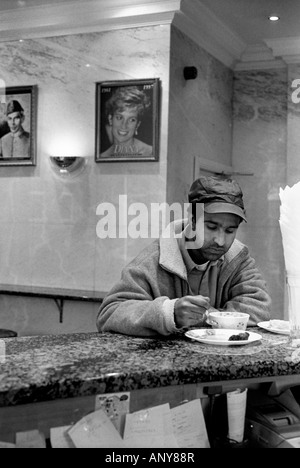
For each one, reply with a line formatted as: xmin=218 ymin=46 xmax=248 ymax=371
xmin=0 ymin=85 xmax=37 ymax=166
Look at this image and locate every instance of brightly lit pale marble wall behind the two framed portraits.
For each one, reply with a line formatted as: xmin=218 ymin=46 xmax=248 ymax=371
xmin=0 ymin=25 xmax=170 ymax=306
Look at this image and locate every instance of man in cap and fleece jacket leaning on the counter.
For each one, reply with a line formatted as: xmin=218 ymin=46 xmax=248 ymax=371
xmin=97 ymin=177 xmax=271 ymax=336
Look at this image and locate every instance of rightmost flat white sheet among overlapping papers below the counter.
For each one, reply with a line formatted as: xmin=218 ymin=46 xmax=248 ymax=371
xmin=171 ymin=398 xmax=210 ymax=448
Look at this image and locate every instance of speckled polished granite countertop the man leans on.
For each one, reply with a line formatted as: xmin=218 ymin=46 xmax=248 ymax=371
xmin=0 ymin=328 xmax=300 ymax=406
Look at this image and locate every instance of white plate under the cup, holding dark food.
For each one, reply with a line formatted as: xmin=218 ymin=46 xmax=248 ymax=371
xmin=185 ymin=328 xmax=262 ymax=346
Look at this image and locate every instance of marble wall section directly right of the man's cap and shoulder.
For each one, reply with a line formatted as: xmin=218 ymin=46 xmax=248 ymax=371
xmin=232 ymin=69 xmax=288 ymax=318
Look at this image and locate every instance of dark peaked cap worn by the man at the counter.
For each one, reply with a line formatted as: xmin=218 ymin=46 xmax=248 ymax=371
xmin=189 ymin=176 xmax=247 ymax=222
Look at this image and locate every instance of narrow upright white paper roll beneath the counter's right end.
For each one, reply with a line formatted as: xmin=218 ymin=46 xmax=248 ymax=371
xmin=227 ymin=388 xmax=248 ymax=442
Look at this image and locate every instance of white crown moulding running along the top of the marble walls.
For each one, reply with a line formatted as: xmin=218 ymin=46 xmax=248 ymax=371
xmin=0 ymin=0 xmax=300 ymax=70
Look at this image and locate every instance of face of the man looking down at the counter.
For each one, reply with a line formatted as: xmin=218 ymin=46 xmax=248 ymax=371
xmin=192 ymin=213 xmax=241 ymax=263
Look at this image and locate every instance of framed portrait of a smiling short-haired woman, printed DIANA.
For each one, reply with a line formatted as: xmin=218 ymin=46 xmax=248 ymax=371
xmin=95 ymin=78 xmax=160 ymax=163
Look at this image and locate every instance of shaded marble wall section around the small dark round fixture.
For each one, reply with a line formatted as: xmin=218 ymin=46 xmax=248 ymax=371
xmin=167 ymin=27 xmax=233 ymax=202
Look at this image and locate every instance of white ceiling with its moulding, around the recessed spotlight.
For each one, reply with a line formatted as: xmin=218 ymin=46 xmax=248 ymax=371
xmin=0 ymin=0 xmax=300 ymax=69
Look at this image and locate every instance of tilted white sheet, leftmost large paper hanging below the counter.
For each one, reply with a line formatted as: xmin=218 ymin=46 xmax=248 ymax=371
xmin=68 ymin=409 xmax=125 ymax=448
